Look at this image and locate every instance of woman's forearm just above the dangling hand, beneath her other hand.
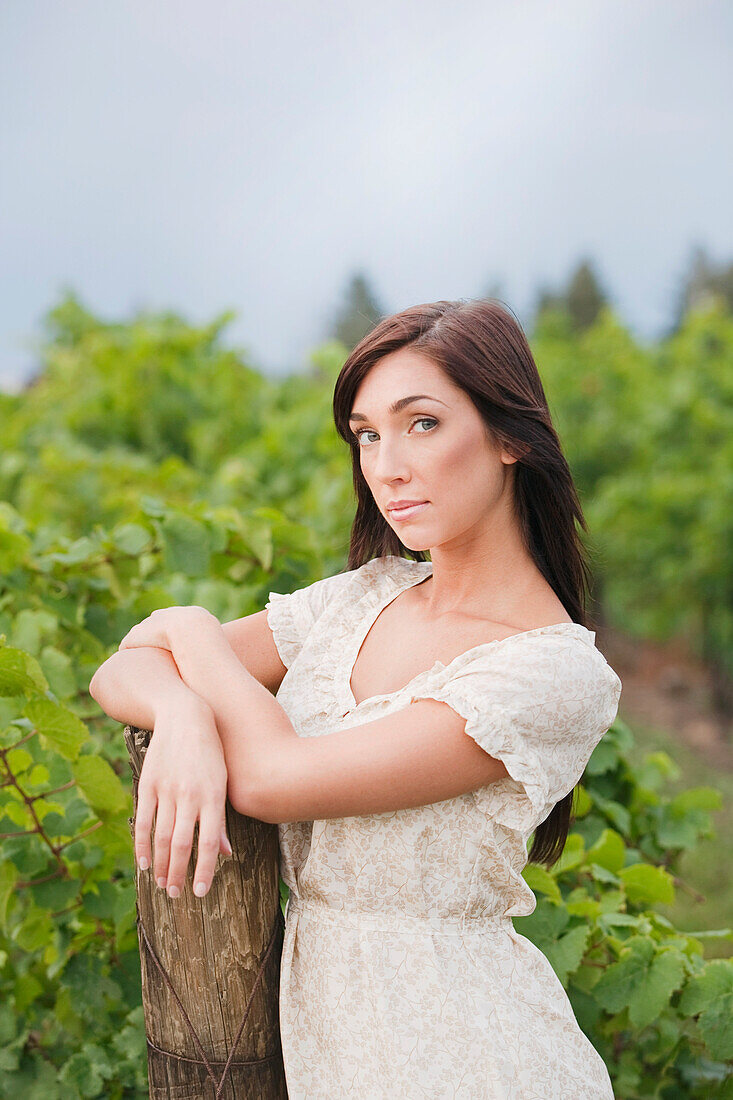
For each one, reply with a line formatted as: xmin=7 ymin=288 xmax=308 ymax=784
xmin=89 ymin=646 xmax=201 ymax=729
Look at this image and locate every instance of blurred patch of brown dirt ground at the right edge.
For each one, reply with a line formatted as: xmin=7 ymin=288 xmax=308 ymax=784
xmin=595 ymin=626 xmax=733 ymax=771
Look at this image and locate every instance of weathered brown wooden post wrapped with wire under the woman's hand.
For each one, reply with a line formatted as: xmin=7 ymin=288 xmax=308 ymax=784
xmin=124 ymin=726 xmax=287 ymax=1100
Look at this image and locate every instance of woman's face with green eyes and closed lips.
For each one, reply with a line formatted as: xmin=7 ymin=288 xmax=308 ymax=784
xmin=349 ymin=348 xmax=516 ymax=550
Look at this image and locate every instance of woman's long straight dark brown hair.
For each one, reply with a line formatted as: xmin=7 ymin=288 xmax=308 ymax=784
xmin=333 ymin=299 xmax=592 ymax=867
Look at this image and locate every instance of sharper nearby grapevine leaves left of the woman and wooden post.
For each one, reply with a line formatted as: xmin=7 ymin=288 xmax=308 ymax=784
xmin=0 ymin=486 xmax=330 ymax=1100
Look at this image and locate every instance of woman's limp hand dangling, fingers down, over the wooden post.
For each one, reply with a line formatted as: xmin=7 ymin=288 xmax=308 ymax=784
xmin=134 ymin=693 xmax=232 ymax=898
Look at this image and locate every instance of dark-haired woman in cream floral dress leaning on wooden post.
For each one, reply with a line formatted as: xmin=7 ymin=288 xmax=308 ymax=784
xmin=89 ymin=300 xmax=621 ymax=1100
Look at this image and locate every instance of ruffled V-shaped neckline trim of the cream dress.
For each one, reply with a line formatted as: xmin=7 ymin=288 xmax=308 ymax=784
xmin=339 ymin=554 xmax=595 ymax=718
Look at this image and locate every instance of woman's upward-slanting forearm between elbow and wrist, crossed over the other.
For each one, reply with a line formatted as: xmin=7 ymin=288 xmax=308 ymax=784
xmin=172 ymin=623 xmax=299 ymax=816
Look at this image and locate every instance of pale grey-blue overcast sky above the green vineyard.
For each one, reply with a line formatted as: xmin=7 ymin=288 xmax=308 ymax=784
xmin=0 ymin=0 xmax=733 ymax=389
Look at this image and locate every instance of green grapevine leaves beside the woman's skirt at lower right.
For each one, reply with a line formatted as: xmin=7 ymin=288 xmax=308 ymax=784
xmin=514 ymin=719 xmax=733 ymax=1098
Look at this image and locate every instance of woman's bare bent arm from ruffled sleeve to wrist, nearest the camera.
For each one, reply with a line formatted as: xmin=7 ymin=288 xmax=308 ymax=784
xmin=160 ymin=614 xmax=508 ymax=824
